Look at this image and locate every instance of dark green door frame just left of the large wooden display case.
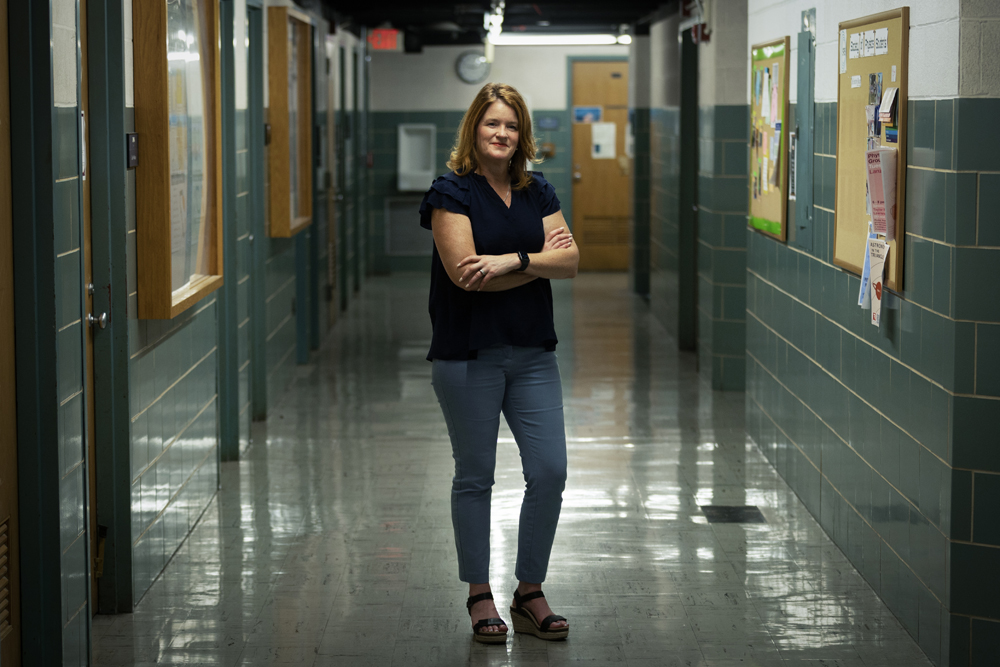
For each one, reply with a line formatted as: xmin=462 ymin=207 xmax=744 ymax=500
xmin=87 ymin=0 xmax=135 ymax=614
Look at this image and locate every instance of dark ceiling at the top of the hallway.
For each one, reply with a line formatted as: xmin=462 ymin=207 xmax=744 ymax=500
xmin=312 ymin=0 xmax=667 ymax=47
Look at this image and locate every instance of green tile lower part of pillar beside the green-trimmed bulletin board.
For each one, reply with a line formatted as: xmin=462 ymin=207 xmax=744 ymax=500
xmin=698 ymin=105 xmax=749 ymax=391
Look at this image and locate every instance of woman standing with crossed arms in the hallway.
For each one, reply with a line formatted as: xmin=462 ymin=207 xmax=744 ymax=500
xmin=420 ymin=83 xmax=580 ymax=643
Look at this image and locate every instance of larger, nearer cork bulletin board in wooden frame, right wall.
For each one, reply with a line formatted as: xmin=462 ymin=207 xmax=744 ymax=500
xmin=833 ymin=7 xmax=910 ymax=292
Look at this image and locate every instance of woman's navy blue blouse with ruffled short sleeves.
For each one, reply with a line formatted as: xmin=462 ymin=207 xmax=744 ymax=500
xmin=420 ymin=171 xmax=560 ymax=360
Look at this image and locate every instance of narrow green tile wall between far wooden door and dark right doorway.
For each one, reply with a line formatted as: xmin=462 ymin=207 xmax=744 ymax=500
xmin=649 ymin=107 xmax=680 ymax=339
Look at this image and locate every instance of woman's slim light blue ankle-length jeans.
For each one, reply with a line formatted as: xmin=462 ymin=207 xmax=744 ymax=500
xmin=432 ymin=345 xmax=566 ymax=584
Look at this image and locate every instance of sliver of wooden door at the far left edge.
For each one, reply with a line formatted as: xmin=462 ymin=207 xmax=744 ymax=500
xmin=0 ymin=0 xmax=21 ymax=665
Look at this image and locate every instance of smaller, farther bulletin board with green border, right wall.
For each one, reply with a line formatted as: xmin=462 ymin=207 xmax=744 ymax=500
xmin=747 ymin=36 xmax=791 ymax=241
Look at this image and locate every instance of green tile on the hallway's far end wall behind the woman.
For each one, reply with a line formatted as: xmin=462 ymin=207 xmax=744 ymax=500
xmin=367 ymin=110 xmax=573 ymax=274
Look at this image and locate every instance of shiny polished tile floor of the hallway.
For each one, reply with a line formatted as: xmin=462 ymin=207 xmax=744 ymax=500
xmin=93 ymin=274 xmax=930 ymax=667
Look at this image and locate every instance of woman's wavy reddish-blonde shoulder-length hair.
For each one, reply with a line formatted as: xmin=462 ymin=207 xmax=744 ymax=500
xmin=448 ymin=83 xmax=538 ymax=190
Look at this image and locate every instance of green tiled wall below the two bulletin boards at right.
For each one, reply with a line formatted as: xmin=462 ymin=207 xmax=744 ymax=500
xmin=748 ymin=99 xmax=1000 ymax=667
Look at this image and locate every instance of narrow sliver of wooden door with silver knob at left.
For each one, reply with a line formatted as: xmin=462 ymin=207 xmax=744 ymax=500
xmin=79 ymin=0 xmax=103 ymax=614
